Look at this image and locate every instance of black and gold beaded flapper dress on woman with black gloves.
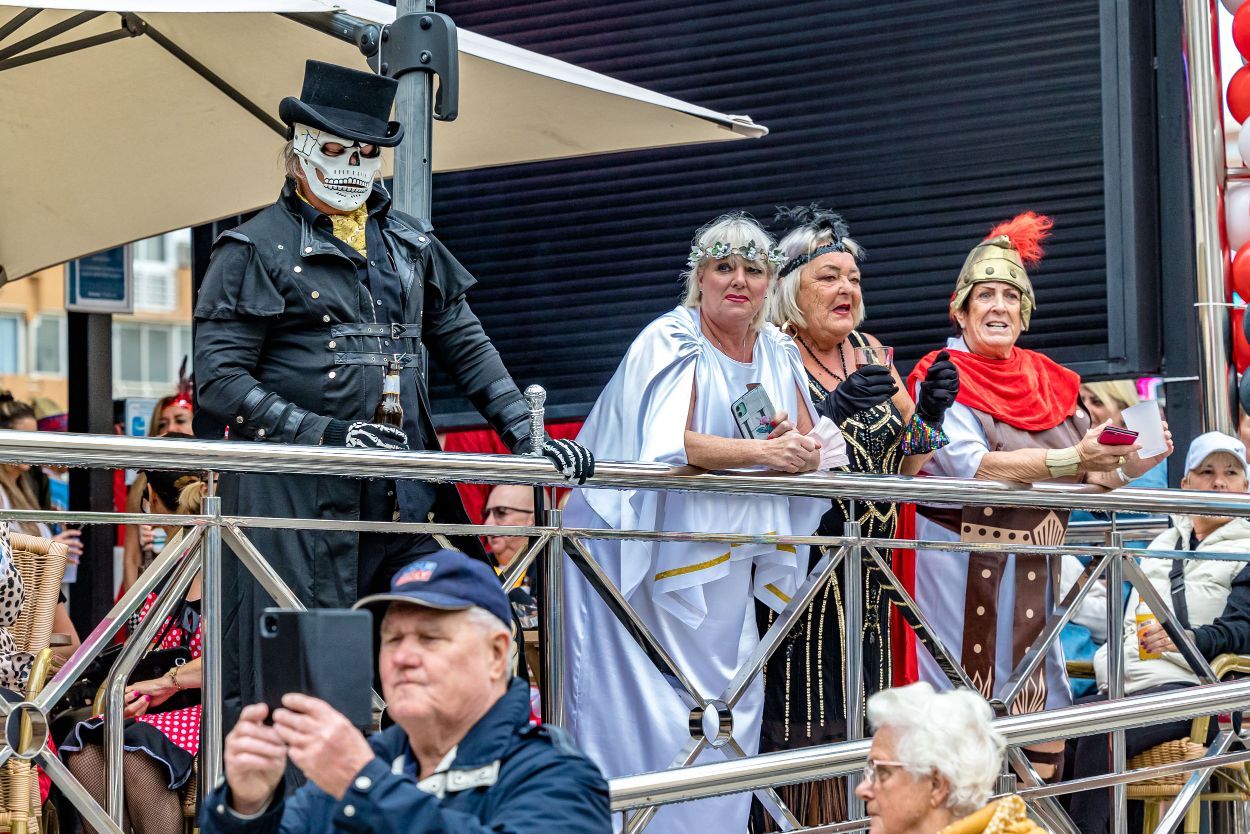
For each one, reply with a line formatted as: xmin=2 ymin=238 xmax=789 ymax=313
xmin=751 ymin=331 xmax=904 ymax=833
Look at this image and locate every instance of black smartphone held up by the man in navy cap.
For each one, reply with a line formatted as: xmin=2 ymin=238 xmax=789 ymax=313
xmin=259 ymin=608 xmax=374 ymax=730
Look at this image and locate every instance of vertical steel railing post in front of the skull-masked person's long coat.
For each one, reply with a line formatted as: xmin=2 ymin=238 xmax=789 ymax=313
xmin=200 ymin=485 xmax=223 ymax=788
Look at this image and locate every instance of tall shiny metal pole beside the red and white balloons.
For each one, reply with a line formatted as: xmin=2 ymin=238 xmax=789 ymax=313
xmin=1184 ymin=0 xmax=1234 ymax=434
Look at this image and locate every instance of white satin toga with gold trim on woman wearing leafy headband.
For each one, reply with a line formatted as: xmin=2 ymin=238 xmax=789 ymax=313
xmin=564 ymin=306 xmax=829 ymax=834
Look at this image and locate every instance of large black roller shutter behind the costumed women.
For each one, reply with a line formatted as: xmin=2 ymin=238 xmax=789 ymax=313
xmin=434 ymin=0 xmax=1145 ymax=425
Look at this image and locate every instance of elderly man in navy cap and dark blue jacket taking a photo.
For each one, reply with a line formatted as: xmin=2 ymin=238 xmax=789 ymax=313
xmin=200 ymin=550 xmax=611 ymax=834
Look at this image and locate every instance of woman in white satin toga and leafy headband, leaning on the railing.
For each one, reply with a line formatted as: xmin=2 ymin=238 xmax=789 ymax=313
xmin=564 ymin=213 xmax=841 ymax=834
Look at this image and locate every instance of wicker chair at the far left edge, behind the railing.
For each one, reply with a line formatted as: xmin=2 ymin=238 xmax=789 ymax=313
xmin=0 ymin=533 xmax=66 ymax=834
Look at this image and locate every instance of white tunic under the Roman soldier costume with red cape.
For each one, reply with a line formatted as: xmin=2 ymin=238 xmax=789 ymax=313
xmin=913 ymin=339 xmax=1073 ymax=709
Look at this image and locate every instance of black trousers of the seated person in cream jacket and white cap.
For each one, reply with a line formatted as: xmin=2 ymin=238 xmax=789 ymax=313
xmin=1064 ymin=683 xmax=1216 ymax=834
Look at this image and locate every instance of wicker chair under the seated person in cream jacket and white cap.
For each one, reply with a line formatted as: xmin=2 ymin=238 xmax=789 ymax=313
xmin=1068 ymin=654 xmax=1250 ymax=834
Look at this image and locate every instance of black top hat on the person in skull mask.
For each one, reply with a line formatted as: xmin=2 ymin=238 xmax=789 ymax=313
xmin=278 ymin=61 xmax=404 ymax=148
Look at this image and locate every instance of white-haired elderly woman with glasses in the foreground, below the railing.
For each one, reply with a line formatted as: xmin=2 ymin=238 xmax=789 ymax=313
xmin=855 ymin=683 xmax=1045 ymax=834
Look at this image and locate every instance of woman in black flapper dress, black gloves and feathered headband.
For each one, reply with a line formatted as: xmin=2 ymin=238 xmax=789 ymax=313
xmin=755 ymin=205 xmax=959 ymax=830
